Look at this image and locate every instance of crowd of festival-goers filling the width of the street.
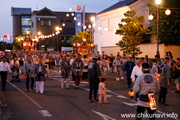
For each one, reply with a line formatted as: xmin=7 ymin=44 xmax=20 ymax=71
xmin=0 ymin=51 xmax=180 ymax=119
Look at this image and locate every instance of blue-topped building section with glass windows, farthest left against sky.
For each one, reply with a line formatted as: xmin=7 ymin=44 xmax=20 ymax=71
xmin=11 ymin=7 xmax=31 ymax=40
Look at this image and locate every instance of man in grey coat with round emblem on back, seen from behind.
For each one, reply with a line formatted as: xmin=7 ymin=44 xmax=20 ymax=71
xmin=133 ymin=63 xmax=159 ymax=120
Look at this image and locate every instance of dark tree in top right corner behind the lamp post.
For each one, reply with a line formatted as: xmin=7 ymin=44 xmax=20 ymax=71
xmin=149 ymin=0 xmax=180 ymax=45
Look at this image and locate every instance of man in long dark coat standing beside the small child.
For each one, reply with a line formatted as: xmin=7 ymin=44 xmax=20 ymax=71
xmin=88 ymin=57 xmax=101 ymax=102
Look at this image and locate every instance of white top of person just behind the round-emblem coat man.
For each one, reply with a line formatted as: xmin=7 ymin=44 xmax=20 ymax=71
xmin=131 ymin=65 xmax=143 ymax=82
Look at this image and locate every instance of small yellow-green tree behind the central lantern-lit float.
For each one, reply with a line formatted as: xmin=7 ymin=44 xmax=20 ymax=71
xmin=71 ymin=31 xmax=93 ymax=51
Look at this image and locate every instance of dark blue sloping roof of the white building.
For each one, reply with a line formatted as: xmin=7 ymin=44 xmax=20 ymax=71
xmin=98 ymin=0 xmax=137 ymax=14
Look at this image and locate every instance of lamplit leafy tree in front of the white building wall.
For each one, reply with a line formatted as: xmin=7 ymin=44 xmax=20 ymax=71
xmin=116 ymin=10 xmax=148 ymax=58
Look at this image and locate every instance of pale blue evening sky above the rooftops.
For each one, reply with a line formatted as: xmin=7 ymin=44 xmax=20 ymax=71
xmin=0 ymin=0 xmax=119 ymax=38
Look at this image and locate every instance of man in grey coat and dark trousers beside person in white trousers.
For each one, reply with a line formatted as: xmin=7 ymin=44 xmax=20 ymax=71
xmin=22 ymin=56 xmax=34 ymax=92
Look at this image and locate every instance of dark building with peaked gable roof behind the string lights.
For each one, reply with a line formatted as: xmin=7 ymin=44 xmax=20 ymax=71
xmin=13 ymin=7 xmax=96 ymax=50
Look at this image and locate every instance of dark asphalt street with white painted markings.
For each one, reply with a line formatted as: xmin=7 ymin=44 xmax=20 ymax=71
xmin=2 ymin=67 xmax=180 ymax=120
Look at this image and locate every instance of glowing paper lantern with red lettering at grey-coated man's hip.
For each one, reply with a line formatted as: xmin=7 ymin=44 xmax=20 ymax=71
xmin=148 ymin=93 xmax=157 ymax=110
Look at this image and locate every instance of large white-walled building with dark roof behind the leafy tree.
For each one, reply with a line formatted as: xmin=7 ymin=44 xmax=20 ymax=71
xmin=94 ymin=0 xmax=180 ymax=58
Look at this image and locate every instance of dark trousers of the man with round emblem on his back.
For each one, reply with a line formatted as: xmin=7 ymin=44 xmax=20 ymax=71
xmin=136 ymin=106 xmax=155 ymax=120
